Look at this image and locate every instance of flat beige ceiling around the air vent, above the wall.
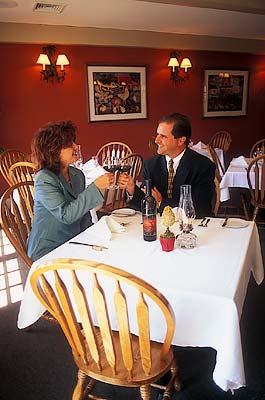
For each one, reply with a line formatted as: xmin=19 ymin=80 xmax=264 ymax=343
xmin=0 ymin=0 xmax=265 ymax=40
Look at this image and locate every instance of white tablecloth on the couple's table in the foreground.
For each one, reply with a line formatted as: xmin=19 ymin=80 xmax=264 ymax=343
xmin=18 ymin=213 xmax=263 ymax=390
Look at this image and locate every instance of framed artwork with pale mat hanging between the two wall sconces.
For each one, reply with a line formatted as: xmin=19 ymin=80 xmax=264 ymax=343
xmin=87 ymin=65 xmax=147 ymax=121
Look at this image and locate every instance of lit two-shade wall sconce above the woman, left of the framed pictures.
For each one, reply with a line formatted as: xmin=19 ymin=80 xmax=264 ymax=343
xmin=37 ymin=46 xmax=70 ymax=82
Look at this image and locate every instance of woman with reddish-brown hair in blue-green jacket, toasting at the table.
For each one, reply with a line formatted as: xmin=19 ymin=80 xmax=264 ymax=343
xmin=27 ymin=121 xmax=114 ymax=261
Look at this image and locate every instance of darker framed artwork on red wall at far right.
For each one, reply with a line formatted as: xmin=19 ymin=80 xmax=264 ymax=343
xmin=203 ymin=69 xmax=249 ymax=117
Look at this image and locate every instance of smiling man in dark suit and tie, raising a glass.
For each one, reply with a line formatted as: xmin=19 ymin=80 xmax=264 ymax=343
xmin=119 ymin=113 xmax=215 ymax=218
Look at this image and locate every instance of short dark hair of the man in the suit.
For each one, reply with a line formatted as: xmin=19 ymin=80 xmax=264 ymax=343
xmin=158 ymin=113 xmax=191 ymax=146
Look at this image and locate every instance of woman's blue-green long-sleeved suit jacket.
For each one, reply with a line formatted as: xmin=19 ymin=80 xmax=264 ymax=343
xmin=27 ymin=167 xmax=103 ymax=261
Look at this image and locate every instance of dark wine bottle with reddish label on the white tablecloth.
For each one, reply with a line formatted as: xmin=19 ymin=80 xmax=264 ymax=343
xmin=142 ymin=179 xmax=156 ymax=242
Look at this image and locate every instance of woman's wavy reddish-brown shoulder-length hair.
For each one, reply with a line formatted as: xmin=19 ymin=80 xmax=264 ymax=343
xmin=31 ymin=121 xmax=76 ymax=174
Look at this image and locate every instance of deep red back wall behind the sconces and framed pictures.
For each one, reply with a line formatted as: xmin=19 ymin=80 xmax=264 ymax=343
xmin=0 ymin=44 xmax=265 ymax=192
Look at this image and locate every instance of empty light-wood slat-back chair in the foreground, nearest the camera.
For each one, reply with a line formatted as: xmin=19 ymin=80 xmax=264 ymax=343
xmin=30 ymin=259 xmax=180 ymax=400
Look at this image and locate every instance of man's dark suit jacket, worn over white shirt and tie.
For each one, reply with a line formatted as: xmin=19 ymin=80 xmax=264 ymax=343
xmin=130 ymin=148 xmax=215 ymax=218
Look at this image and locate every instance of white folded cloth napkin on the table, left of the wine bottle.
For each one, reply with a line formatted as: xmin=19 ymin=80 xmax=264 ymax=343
xmin=76 ymin=215 xmax=126 ymax=244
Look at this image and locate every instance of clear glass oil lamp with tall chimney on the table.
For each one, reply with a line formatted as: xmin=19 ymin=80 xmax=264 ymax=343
xmin=176 ymin=185 xmax=197 ymax=249
